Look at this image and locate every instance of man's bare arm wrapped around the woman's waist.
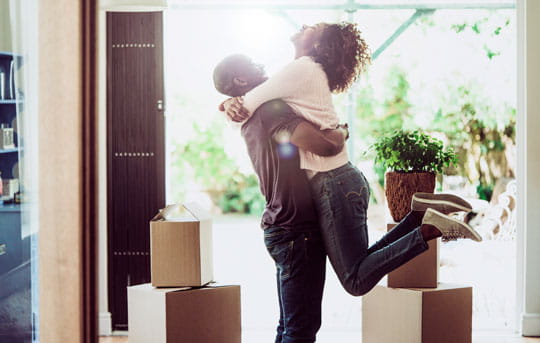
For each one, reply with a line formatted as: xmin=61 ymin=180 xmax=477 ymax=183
xmin=290 ymin=121 xmax=349 ymax=156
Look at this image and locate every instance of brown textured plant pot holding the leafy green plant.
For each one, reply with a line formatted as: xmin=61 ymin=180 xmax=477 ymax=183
xmin=384 ymin=172 xmax=436 ymax=222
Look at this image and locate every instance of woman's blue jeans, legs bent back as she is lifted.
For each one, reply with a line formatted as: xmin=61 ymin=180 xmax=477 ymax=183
xmin=311 ymin=163 xmax=428 ymax=296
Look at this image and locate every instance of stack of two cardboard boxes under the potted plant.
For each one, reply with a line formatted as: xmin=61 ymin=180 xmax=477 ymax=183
xmin=362 ymin=224 xmax=472 ymax=343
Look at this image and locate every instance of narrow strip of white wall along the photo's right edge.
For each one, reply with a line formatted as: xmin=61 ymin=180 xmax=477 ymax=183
xmin=518 ymin=0 xmax=540 ymax=336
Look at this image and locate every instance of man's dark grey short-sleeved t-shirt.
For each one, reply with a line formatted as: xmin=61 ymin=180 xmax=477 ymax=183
xmin=242 ymin=100 xmax=318 ymax=230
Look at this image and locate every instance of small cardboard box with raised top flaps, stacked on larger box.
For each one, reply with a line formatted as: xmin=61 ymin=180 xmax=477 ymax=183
xmin=150 ymin=204 xmax=214 ymax=287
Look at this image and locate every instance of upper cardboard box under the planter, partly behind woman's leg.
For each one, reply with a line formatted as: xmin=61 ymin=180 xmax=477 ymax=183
xmin=387 ymin=224 xmax=440 ymax=288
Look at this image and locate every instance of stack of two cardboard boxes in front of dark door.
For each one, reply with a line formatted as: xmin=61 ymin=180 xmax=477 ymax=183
xmin=128 ymin=204 xmax=241 ymax=343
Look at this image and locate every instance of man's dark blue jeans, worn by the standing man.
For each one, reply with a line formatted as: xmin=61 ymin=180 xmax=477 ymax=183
xmin=264 ymin=227 xmax=326 ymax=343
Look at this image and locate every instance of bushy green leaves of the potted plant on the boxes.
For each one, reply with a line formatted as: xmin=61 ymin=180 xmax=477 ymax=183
xmin=372 ymin=130 xmax=457 ymax=173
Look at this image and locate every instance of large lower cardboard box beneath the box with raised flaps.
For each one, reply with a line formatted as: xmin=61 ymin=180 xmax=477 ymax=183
xmin=128 ymin=284 xmax=241 ymax=343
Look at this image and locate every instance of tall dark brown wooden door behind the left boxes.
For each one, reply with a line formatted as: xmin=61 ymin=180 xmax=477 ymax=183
xmin=107 ymin=12 xmax=165 ymax=330
